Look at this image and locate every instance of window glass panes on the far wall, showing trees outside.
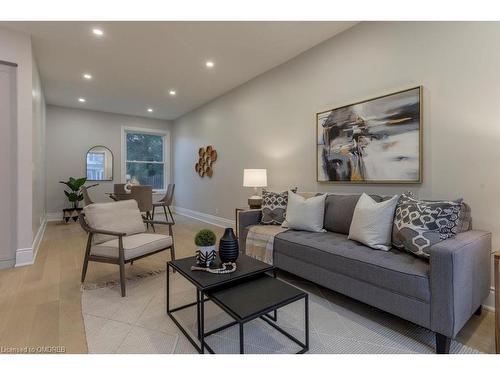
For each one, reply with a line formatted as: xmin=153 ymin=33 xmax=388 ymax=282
xmin=122 ymin=129 xmax=168 ymax=194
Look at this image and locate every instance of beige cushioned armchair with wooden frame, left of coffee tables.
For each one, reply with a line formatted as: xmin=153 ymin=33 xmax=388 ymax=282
xmin=79 ymin=199 xmax=175 ymax=297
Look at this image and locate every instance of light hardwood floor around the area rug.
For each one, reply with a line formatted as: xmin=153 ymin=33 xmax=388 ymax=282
xmin=0 ymin=216 xmax=495 ymax=353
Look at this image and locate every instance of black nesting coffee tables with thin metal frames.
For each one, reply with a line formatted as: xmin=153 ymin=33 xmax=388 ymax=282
xmin=167 ymin=254 xmax=309 ymax=354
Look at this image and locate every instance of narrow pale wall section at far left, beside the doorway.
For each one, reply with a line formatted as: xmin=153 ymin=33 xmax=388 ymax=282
xmin=0 ymin=28 xmax=38 ymax=263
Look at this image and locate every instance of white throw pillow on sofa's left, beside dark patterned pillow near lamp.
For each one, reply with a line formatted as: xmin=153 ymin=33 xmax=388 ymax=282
xmin=281 ymin=190 xmax=326 ymax=232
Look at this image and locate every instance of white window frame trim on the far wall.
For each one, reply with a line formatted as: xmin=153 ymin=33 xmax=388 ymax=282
xmin=121 ymin=126 xmax=172 ymax=193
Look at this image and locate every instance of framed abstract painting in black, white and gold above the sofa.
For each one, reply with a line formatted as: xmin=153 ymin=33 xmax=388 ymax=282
xmin=316 ymin=87 xmax=422 ymax=183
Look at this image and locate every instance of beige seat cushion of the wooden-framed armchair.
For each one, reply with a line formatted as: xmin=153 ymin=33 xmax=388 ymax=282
xmin=90 ymin=233 xmax=172 ymax=260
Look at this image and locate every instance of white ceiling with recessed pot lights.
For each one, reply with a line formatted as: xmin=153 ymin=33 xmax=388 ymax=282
xmin=0 ymin=22 xmax=355 ymax=120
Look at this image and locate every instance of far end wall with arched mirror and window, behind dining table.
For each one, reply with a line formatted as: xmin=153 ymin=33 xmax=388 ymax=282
xmin=46 ymin=105 xmax=170 ymax=214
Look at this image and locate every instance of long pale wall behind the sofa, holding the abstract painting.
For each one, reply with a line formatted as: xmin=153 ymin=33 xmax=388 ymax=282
xmin=174 ymin=22 xmax=500 ymax=302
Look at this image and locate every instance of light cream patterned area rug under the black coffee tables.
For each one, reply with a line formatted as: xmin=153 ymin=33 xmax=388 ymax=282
xmin=82 ymin=271 xmax=480 ymax=354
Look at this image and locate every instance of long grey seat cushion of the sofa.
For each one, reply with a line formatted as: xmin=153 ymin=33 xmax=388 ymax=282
xmin=274 ymin=230 xmax=430 ymax=302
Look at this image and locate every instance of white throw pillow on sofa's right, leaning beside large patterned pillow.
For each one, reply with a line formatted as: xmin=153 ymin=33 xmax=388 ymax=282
xmin=348 ymin=193 xmax=399 ymax=251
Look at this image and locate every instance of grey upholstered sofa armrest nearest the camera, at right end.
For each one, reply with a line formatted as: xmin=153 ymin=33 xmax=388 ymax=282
xmin=430 ymin=230 xmax=491 ymax=338
